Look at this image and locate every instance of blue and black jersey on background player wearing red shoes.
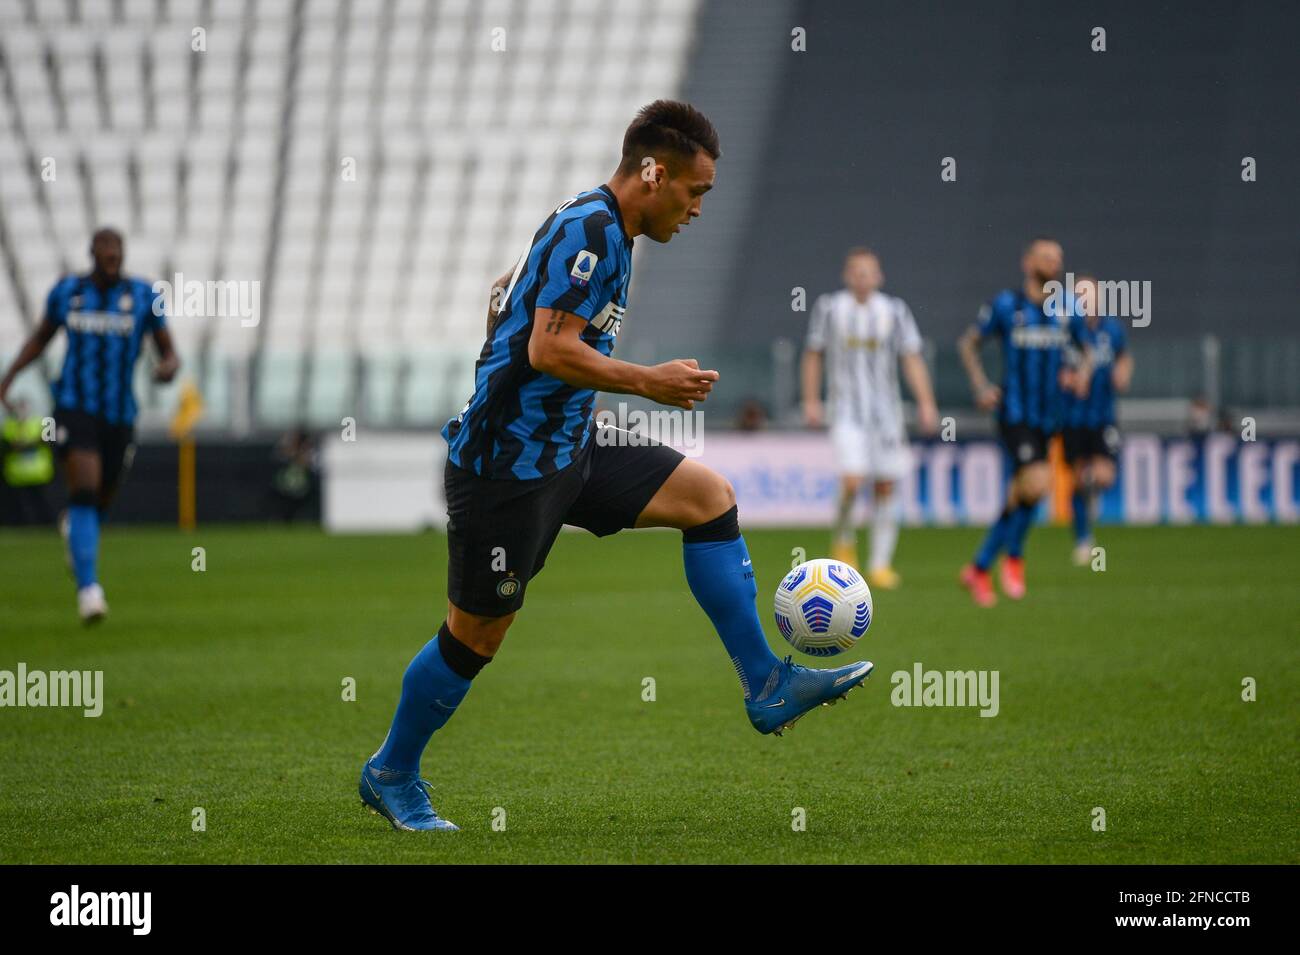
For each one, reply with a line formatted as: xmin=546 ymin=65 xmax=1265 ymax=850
xmin=979 ymin=288 xmax=1083 ymax=434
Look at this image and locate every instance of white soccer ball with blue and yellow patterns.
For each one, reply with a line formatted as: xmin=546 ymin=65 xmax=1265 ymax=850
xmin=776 ymin=557 xmax=871 ymax=656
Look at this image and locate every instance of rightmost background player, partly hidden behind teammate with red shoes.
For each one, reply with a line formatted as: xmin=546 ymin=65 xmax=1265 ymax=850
xmin=1061 ymin=274 xmax=1134 ymax=567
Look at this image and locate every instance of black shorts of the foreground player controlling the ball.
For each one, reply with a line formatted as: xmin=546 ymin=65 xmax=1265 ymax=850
xmin=443 ymin=431 xmax=683 ymax=617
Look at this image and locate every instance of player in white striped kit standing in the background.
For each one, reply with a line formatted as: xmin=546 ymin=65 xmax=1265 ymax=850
xmin=801 ymin=248 xmax=939 ymax=590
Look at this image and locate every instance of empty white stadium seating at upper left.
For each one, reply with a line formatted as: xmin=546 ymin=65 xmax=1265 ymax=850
xmin=0 ymin=0 xmax=697 ymax=430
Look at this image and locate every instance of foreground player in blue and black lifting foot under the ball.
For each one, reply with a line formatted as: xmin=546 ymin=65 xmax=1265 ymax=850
xmin=359 ymin=100 xmax=872 ymax=829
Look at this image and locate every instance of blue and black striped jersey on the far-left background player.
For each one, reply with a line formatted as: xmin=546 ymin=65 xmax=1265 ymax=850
xmin=46 ymin=275 xmax=166 ymax=425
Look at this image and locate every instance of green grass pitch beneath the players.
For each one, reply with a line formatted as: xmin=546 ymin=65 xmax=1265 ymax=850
xmin=0 ymin=528 xmax=1300 ymax=863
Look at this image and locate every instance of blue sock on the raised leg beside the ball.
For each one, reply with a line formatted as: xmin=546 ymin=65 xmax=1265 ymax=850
xmin=681 ymin=509 xmax=781 ymax=700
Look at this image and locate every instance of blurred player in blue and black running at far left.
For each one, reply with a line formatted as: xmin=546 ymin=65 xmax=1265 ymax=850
xmin=0 ymin=229 xmax=181 ymax=624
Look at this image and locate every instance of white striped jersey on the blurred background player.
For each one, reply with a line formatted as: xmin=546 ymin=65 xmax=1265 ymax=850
xmin=807 ymin=288 xmax=920 ymax=440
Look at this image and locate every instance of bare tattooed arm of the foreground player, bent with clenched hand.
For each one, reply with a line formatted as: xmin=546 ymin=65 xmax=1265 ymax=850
xmin=528 ymin=308 xmax=718 ymax=408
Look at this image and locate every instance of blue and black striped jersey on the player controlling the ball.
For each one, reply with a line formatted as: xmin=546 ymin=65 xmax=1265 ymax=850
xmin=442 ymin=186 xmax=632 ymax=479
